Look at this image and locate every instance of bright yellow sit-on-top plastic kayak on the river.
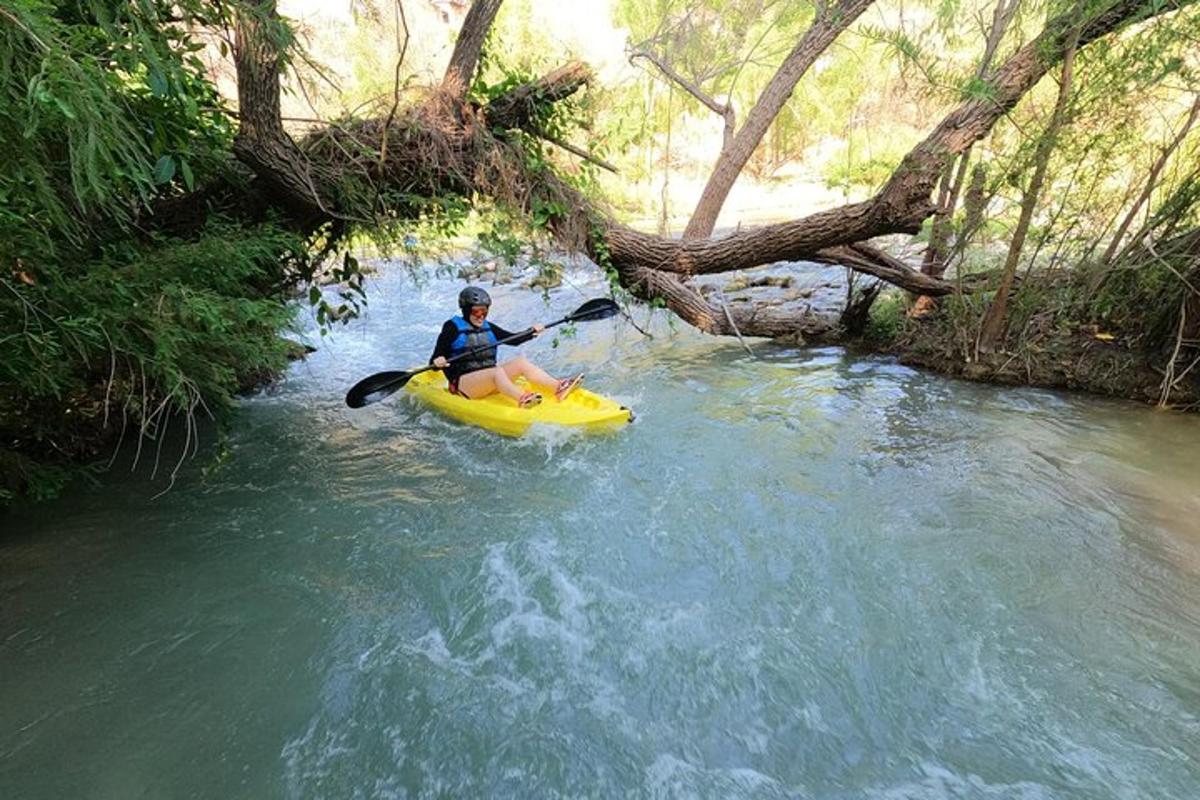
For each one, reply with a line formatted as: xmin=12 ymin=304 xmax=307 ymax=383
xmin=406 ymin=372 xmax=634 ymax=437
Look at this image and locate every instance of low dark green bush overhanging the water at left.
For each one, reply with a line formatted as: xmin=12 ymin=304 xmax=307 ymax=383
xmin=0 ymin=224 xmax=305 ymax=501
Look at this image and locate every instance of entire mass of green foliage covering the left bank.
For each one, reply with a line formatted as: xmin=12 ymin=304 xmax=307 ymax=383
xmin=0 ymin=0 xmax=321 ymax=503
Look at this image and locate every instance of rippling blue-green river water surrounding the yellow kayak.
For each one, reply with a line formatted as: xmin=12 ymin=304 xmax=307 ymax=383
xmin=0 ymin=266 xmax=1200 ymax=799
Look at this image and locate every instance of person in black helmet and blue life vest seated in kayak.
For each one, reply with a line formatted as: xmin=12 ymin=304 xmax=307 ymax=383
xmin=430 ymin=287 xmax=583 ymax=408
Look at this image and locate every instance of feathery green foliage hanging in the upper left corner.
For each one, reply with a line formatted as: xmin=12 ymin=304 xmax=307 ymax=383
xmin=0 ymin=0 xmax=232 ymax=254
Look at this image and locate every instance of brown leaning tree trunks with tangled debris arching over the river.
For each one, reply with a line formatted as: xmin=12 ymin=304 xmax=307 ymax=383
xmin=213 ymin=0 xmax=1192 ymax=336
